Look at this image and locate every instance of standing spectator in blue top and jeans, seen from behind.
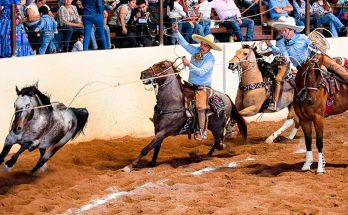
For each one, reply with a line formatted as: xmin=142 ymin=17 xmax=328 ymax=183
xmin=82 ymin=0 xmax=108 ymax=50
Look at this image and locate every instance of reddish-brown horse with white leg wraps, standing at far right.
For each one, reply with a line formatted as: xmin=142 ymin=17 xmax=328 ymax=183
xmin=294 ymin=55 xmax=348 ymax=174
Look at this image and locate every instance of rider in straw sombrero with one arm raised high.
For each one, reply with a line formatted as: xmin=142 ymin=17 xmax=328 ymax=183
xmin=172 ymin=23 xmax=222 ymax=140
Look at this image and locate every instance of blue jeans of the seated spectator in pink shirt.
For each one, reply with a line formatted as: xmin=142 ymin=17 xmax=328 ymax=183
xmin=223 ymin=18 xmax=254 ymax=41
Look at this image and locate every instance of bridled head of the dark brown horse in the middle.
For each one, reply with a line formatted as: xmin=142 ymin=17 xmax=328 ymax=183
xmin=140 ymin=61 xmax=175 ymax=85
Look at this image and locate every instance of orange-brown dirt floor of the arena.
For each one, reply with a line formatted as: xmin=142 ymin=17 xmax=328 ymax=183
xmin=0 ymin=113 xmax=348 ymax=215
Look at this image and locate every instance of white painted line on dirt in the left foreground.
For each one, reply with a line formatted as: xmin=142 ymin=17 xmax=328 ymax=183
xmin=64 ymin=179 xmax=168 ymax=215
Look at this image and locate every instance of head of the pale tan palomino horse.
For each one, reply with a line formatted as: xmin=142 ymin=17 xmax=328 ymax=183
xmin=228 ymin=44 xmax=256 ymax=70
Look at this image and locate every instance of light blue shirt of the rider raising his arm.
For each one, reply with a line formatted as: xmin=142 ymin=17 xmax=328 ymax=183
xmin=174 ymin=32 xmax=215 ymax=87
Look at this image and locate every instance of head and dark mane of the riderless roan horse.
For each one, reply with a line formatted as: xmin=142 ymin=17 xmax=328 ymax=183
xmin=11 ymin=83 xmax=52 ymax=134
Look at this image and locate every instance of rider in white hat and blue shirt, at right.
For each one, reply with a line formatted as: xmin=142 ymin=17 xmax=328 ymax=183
xmin=268 ymin=17 xmax=348 ymax=109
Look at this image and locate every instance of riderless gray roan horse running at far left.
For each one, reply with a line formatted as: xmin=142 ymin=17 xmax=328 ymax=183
xmin=0 ymin=83 xmax=88 ymax=174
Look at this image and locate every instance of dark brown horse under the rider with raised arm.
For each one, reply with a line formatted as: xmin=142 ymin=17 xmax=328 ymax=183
xmin=123 ymin=61 xmax=247 ymax=172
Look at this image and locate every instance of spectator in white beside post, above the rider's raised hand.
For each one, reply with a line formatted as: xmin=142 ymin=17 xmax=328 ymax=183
xmin=167 ymin=0 xmax=186 ymax=45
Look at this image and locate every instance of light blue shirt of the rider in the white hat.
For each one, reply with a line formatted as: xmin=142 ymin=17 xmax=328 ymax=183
xmin=277 ymin=34 xmax=313 ymax=66
